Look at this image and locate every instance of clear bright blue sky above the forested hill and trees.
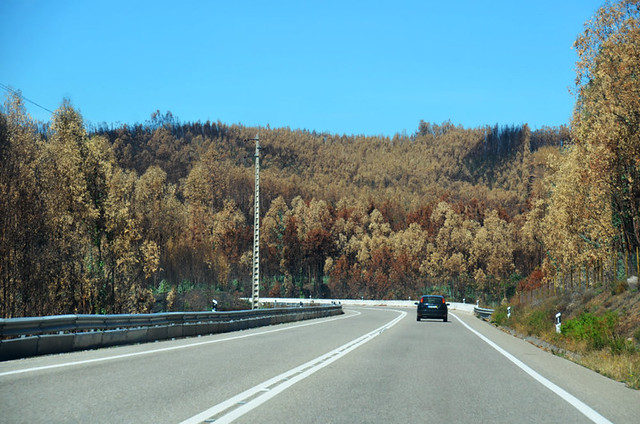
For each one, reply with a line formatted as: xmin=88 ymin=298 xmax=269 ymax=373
xmin=0 ymin=0 xmax=604 ymax=136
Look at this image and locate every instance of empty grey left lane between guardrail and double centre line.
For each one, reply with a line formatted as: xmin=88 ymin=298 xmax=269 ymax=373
xmin=0 ymin=311 xmax=388 ymax=423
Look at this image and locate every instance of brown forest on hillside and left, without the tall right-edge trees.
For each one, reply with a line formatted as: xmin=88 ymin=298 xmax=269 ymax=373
xmin=0 ymin=96 xmax=570 ymax=316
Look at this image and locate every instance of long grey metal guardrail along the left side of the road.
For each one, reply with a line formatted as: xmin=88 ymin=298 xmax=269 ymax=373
xmin=0 ymin=305 xmax=343 ymax=361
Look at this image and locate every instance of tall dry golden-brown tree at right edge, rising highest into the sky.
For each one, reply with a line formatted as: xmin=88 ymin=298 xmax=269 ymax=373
xmin=572 ymin=0 xmax=640 ymax=255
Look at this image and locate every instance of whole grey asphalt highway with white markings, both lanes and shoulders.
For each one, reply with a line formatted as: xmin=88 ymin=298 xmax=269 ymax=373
xmin=0 ymin=307 xmax=640 ymax=423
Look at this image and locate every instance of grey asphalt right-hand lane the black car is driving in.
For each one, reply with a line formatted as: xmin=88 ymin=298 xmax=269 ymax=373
xmin=237 ymin=308 xmax=608 ymax=423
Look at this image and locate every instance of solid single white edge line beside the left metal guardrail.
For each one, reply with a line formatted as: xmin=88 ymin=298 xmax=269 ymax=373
xmin=0 ymin=310 xmax=361 ymax=377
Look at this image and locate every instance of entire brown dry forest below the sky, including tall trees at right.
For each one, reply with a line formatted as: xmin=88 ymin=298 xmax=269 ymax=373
xmin=0 ymin=1 xmax=640 ymax=317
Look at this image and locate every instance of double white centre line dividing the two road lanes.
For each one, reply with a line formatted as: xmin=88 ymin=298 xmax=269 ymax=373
xmin=180 ymin=310 xmax=407 ymax=424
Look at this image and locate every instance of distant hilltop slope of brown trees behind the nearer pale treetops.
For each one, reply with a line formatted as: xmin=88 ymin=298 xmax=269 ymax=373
xmin=93 ymin=112 xmax=569 ymax=217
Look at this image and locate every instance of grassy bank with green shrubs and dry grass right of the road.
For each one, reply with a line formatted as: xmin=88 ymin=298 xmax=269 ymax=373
xmin=491 ymin=288 xmax=640 ymax=389
